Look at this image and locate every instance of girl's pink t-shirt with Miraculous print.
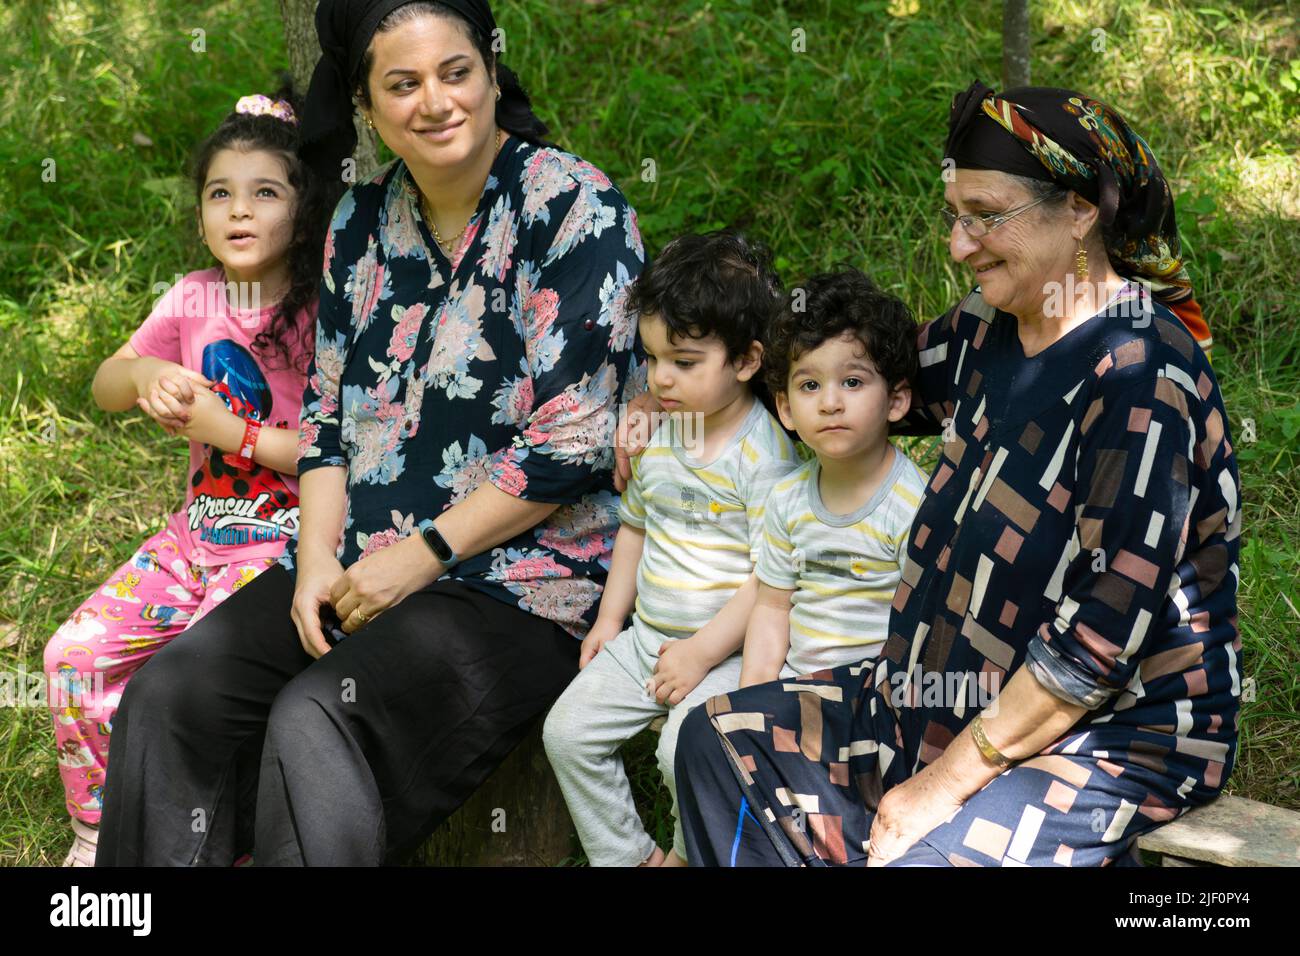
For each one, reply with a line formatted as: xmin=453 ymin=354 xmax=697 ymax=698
xmin=130 ymin=268 xmax=316 ymax=567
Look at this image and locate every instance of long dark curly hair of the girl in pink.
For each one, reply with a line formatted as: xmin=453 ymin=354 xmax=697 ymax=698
xmin=190 ymin=75 xmax=345 ymax=373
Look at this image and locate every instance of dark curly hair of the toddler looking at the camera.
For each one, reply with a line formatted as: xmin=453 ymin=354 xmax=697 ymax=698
xmin=763 ymin=269 xmax=919 ymax=393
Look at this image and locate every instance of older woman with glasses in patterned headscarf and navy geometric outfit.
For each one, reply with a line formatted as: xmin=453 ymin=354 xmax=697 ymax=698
xmin=677 ymin=83 xmax=1242 ymax=866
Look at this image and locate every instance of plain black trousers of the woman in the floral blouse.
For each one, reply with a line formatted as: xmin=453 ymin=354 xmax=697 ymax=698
xmin=104 ymin=566 xmax=579 ymax=866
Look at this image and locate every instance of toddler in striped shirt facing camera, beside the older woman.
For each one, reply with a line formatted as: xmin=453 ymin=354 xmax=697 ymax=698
xmin=741 ymin=269 xmax=926 ymax=687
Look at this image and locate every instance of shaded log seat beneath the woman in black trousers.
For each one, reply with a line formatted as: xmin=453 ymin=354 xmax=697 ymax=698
xmin=411 ymin=718 xmax=576 ymax=866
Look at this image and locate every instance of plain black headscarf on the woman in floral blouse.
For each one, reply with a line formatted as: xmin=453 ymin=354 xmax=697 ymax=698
xmin=299 ymin=0 xmax=550 ymax=179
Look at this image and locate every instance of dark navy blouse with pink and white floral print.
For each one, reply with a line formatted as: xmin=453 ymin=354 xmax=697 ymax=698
xmin=281 ymin=137 xmax=645 ymax=636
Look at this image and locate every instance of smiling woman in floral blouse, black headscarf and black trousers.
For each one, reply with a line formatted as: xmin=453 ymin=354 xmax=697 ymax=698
xmin=99 ymin=0 xmax=645 ymax=865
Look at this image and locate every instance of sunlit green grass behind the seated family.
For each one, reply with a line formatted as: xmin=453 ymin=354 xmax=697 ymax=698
xmin=0 ymin=0 xmax=1300 ymax=864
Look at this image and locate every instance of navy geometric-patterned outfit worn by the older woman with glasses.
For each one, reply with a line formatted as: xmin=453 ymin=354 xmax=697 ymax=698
xmin=710 ymin=285 xmax=1242 ymax=865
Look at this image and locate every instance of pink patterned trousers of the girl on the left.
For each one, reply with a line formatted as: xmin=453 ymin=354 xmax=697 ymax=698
xmin=44 ymin=522 xmax=276 ymax=823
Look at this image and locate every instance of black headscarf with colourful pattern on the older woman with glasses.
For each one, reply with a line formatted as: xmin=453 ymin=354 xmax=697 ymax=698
xmin=945 ymin=81 xmax=1212 ymax=354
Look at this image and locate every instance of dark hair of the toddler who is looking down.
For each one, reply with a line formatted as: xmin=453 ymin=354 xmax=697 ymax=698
xmin=627 ymin=229 xmax=783 ymax=360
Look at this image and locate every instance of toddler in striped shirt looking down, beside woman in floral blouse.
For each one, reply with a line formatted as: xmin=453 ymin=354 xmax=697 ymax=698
xmin=542 ymin=232 xmax=800 ymax=866
